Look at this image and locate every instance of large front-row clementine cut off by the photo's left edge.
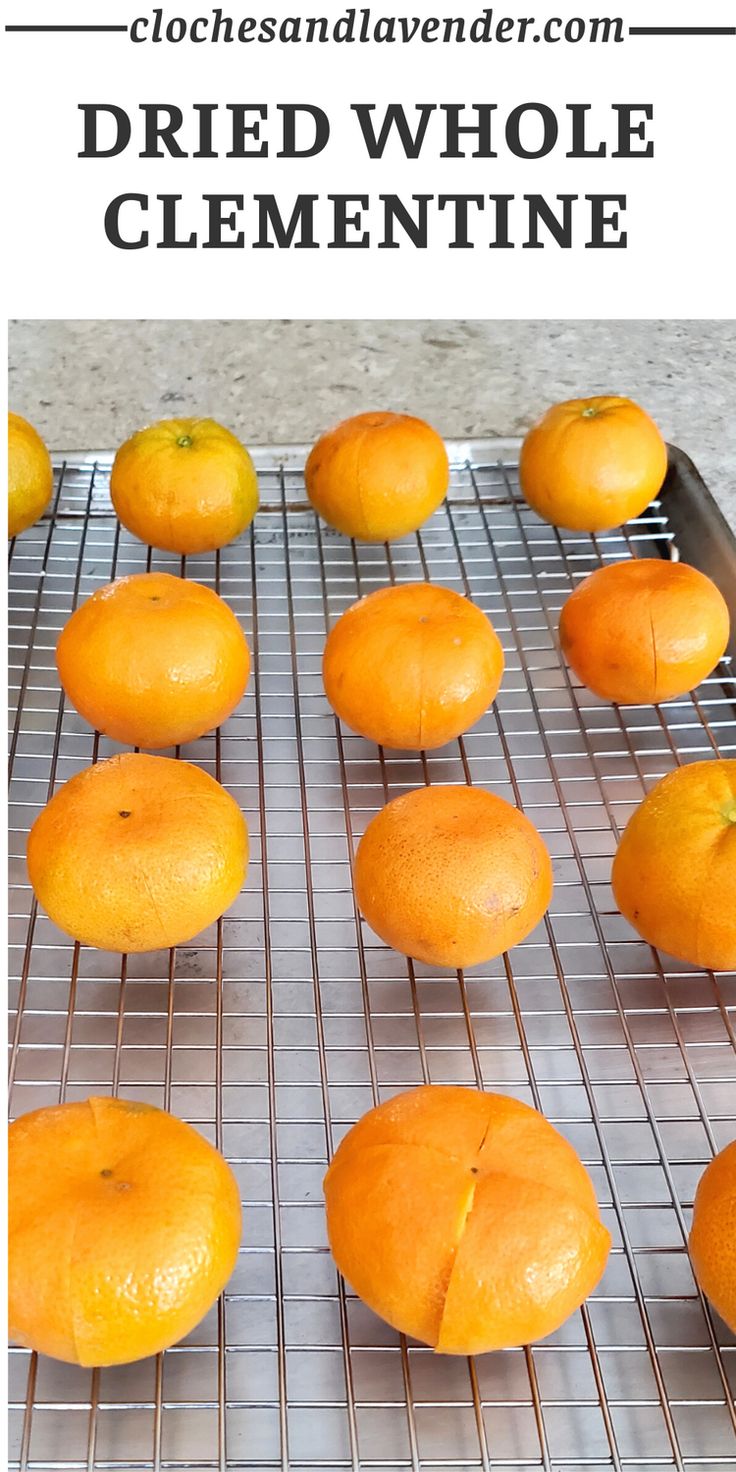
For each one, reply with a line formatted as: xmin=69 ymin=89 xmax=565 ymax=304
xmin=9 ymin=1098 xmax=241 ymax=1366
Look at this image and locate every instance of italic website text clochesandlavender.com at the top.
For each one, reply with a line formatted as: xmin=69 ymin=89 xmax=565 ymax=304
xmin=128 ymin=6 xmax=629 ymax=46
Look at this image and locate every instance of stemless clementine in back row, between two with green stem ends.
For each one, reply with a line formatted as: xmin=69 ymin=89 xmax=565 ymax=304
xmin=305 ymin=414 xmax=449 ymax=542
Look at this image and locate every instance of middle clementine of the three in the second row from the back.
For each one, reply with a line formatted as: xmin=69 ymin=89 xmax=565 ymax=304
xmin=322 ymin=583 xmax=503 ymax=751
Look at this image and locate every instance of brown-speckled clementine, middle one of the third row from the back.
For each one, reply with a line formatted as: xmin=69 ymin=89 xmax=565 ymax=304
xmin=355 ymin=788 xmax=552 ymax=967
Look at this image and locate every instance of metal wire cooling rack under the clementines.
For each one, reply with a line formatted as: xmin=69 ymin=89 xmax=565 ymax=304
xmin=10 ymin=445 xmax=736 ymax=1472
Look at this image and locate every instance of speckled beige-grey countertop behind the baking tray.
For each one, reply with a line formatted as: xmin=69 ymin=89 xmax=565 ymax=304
xmin=9 ymin=321 xmax=736 ymax=530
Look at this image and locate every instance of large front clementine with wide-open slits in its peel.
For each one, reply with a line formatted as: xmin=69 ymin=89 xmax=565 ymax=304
xmin=324 ymin=1085 xmax=611 ymax=1354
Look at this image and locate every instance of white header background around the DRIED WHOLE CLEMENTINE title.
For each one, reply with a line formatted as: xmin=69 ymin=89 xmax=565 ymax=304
xmin=3 ymin=0 xmax=736 ymax=318
